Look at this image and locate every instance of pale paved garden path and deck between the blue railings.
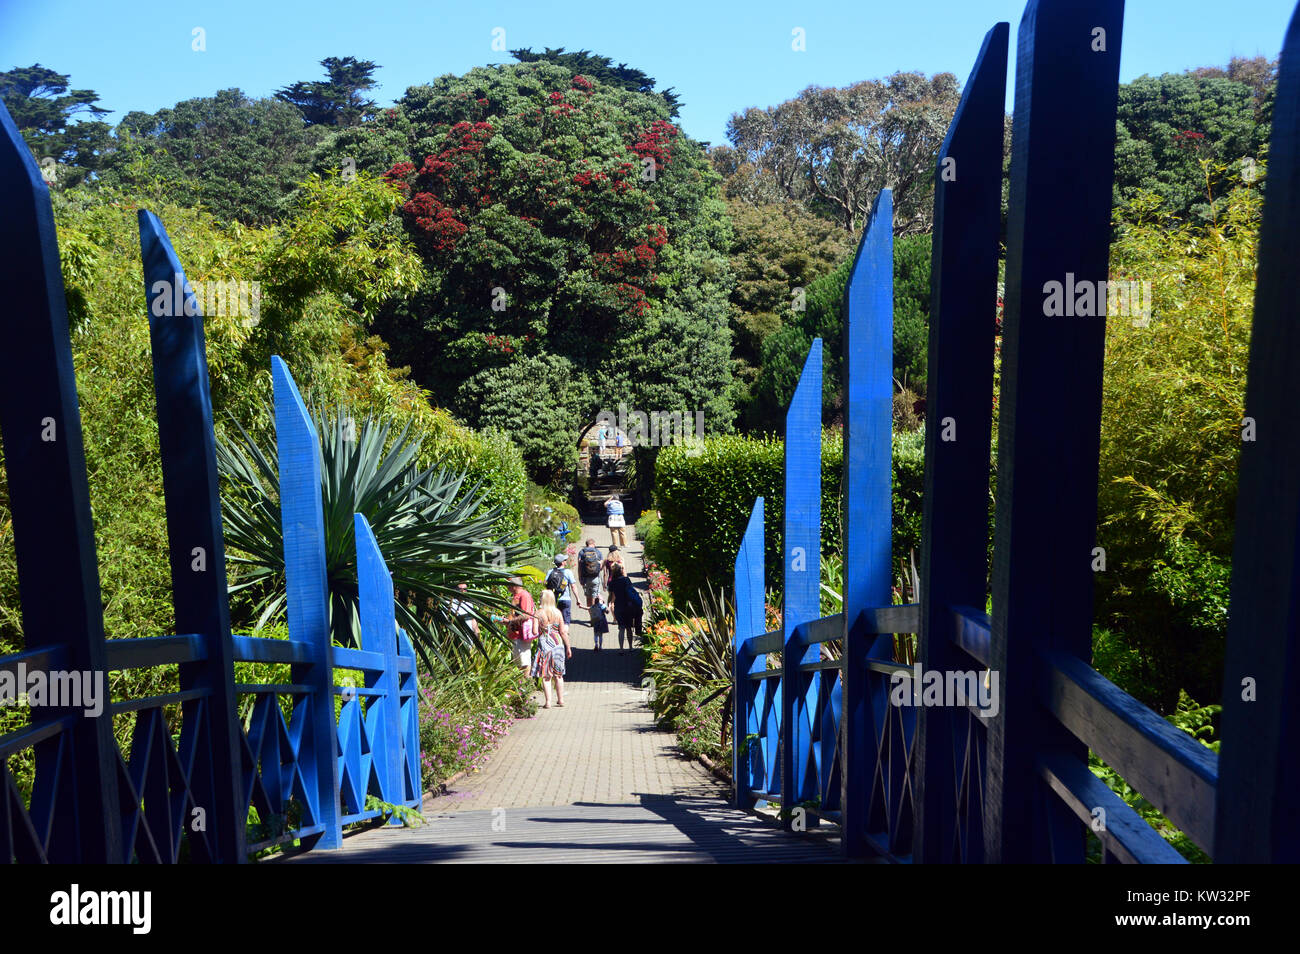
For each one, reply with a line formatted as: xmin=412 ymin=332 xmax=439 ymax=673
xmin=285 ymin=525 xmax=840 ymax=863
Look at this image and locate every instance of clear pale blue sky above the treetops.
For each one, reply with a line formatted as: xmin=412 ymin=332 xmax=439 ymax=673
xmin=0 ymin=0 xmax=1295 ymax=143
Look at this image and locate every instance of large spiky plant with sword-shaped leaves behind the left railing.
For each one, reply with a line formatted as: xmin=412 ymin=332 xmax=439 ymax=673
xmin=217 ymin=408 xmax=529 ymax=668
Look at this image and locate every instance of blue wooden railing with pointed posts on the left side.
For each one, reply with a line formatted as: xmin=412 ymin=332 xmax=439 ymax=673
xmin=0 ymin=98 xmax=421 ymax=863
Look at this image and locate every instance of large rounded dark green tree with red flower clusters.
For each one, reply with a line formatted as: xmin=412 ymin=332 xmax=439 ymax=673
xmin=340 ymin=62 xmax=732 ymax=478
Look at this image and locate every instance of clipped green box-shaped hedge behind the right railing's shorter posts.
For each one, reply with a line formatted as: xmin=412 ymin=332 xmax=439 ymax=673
xmin=655 ymin=430 xmax=924 ymax=602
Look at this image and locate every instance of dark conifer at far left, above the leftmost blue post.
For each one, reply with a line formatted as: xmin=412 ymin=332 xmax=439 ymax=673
xmin=0 ymin=62 xmax=112 ymax=185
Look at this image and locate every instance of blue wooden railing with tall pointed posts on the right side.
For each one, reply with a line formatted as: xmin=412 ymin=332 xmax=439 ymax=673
xmin=733 ymin=0 xmax=1300 ymax=863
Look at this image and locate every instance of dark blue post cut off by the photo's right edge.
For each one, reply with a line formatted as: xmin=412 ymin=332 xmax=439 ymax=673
xmin=1214 ymin=0 xmax=1300 ymax=863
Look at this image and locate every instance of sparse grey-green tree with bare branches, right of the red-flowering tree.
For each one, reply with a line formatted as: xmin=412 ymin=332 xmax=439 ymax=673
xmin=727 ymin=73 xmax=959 ymax=235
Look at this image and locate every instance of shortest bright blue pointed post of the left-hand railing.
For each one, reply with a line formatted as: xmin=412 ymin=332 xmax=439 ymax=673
xmin=352 ymin=513 xmax=403 ymax=824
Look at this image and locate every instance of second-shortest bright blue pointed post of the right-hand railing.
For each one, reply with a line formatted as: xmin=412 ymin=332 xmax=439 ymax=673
xmin=781 ymin=338 xmax=822 ymax=824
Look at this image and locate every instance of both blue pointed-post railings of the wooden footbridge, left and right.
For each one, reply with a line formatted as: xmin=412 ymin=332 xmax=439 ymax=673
xmin=0 ymin=0 xmax=1300 ymax=862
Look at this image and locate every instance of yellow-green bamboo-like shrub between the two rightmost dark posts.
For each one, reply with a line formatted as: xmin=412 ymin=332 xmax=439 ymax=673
xmin=1096 ymin=165 xmax=1261 ymax=712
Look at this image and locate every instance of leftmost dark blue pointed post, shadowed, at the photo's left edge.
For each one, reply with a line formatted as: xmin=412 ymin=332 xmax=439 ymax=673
xmin=0 ymin=98 xmax=124 ymax=864
